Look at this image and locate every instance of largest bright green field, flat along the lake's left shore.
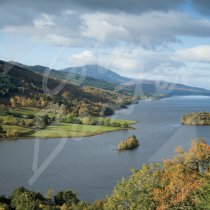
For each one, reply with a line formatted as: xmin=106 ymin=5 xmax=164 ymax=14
xmin=30 ymin=123 xmax=122 ymax=138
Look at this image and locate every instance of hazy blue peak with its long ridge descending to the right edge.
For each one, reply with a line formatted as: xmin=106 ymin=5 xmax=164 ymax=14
xmin=61 ymin=64 xmax=210 ymax=96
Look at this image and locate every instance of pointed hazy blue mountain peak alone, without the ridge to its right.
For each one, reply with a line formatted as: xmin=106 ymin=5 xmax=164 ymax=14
xmin=61 ymin=64 xmax=131 ymax=84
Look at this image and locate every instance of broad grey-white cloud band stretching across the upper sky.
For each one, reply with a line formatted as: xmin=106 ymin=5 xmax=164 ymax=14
xmin=4 ymin=9 xmax=210 ymax=50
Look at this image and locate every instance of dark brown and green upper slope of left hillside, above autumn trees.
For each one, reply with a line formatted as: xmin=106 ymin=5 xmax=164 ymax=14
xmin=0 ymin=61 xmax=132 ymax=104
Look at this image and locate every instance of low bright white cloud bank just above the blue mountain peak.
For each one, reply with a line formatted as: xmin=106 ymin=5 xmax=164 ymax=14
xmin=65 ymin=46 xmax=184 ymax=78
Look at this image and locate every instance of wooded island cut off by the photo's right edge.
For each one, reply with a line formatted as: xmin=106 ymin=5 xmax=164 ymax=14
xmin=181 ymin=112 xmax=210 ymax=125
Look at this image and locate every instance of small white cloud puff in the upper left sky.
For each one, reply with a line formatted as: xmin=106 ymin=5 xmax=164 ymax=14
xmin=33 ymin=14 xmax=55 ymax=29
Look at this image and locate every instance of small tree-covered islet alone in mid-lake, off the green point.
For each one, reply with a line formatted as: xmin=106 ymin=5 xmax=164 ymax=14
xmin=117 ymin=135 xmax=139 ymax=151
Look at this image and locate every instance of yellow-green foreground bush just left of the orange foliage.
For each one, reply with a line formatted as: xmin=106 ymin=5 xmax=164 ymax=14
xmin=104 ymin=164 xmax=160 ymax=210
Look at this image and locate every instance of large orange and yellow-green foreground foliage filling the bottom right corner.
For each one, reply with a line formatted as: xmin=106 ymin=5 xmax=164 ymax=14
xmin=104 ymin=139 xmax=210 ymax=210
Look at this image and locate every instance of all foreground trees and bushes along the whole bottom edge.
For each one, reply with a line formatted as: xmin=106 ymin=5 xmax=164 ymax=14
xmin=0 ymin=139 xmax=210 ymax=210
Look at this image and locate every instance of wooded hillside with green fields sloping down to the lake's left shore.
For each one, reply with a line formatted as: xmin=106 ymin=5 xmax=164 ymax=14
xmin=0 ymin=61 xmax=136 ymax=138
